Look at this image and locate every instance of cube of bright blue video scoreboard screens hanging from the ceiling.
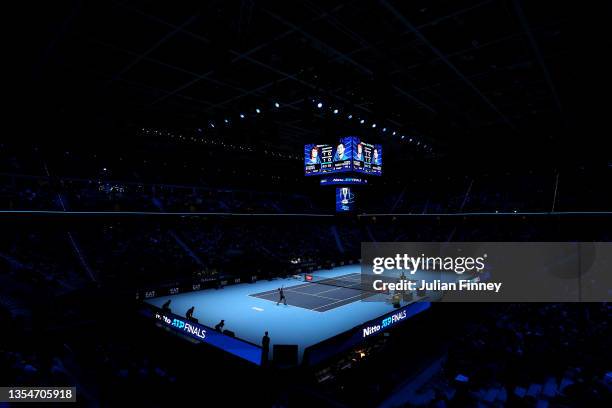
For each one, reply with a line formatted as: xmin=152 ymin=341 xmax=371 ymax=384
xmin=304 ymin=136 xmax=382 ymax=176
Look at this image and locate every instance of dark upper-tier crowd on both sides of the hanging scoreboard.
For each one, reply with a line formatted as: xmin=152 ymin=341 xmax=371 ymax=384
xmin=0 ymin=170 xmax=612 ymax=214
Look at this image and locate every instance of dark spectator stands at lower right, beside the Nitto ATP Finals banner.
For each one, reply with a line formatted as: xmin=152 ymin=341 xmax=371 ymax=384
xmin=310 ymin=303 xmax=612 ymax=407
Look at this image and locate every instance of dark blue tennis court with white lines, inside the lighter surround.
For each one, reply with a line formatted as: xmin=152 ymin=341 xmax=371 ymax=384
xmin=250 ymin=273 xmax=382 ymax=312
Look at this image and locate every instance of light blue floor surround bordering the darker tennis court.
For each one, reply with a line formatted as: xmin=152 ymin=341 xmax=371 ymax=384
xmin=147 ymin=265 xmax=428 ymax=358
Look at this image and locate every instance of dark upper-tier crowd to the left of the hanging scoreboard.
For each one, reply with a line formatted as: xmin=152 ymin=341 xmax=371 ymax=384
xmin=0 ymin=175 xmax=321 ymax=214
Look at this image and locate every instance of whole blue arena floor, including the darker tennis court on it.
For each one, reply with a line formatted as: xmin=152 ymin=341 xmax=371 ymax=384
xmin=146 ymin=265 xmax=426 ymax=362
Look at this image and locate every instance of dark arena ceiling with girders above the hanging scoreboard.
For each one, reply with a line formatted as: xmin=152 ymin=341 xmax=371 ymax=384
xmin=17 ymin=0 xmax=605 ymax=163
